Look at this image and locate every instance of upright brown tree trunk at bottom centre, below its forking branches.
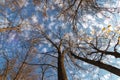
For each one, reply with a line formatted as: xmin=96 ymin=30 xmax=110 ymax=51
xmin=58 ymin=54 xmax=68 ymax=80
